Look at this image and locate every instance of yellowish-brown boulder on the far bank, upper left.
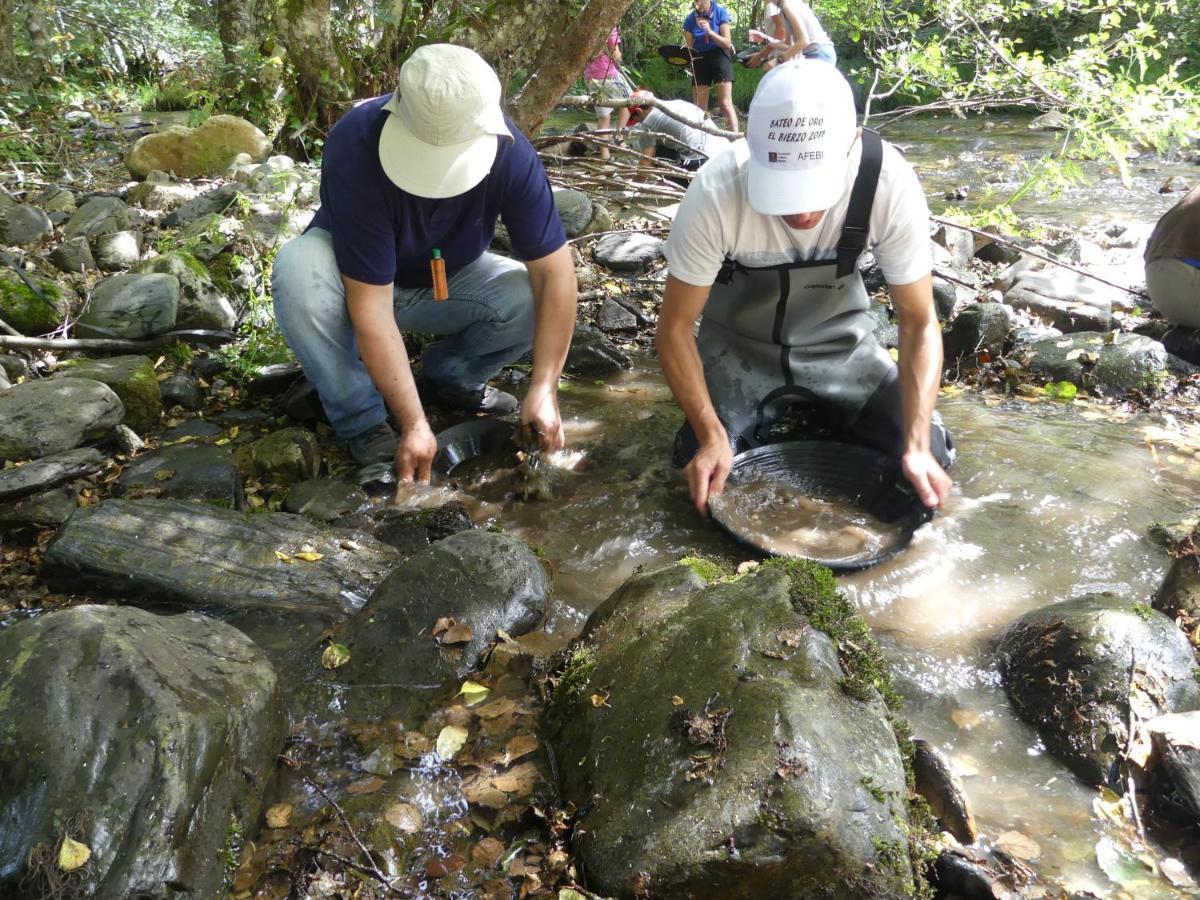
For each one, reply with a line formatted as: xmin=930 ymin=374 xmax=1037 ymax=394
xmin=125 ymin=115 xmax=271 ymax=178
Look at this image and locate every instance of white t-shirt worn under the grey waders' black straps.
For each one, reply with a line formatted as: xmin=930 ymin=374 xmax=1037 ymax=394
xmin=662 ymin=140 xmax=932 ymax=286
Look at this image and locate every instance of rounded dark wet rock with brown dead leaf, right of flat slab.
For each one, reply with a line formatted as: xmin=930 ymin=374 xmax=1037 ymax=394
xmin=337 ymin=529 xmax=550 ymax=686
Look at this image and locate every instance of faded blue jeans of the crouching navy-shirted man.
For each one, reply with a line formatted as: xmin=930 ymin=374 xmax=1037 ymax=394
xmin=271 ymin=228 xmax=534 ymax=440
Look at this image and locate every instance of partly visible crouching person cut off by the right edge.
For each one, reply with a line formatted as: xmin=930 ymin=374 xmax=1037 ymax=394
xmin=1144 ymin=185 xmax=1200 ymax=366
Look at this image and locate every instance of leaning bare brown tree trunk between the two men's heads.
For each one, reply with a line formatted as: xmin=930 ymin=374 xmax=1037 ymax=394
xmin=511 ymin=0 xmax=632 ymax=136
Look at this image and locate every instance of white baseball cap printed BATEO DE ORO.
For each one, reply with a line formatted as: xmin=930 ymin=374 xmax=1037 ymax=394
xmin=746 ymin=59 xmax=858 ymax=216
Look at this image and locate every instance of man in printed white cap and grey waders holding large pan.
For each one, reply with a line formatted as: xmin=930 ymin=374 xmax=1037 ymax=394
xmin=658 ymin=60 xmax=954 ymax=514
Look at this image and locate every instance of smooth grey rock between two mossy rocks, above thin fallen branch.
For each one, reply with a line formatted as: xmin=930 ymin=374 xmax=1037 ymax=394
xmin=78 ymin=274 xmax=179 ymax=340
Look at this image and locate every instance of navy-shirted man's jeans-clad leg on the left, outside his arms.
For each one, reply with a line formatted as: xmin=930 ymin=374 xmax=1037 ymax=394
xmin=271 ymin=228 xmax=388 ymax=440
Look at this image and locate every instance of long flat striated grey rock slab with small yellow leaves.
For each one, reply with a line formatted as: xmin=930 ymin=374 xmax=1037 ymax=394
xmin=42 ymin=499 xmax=397 ymax=641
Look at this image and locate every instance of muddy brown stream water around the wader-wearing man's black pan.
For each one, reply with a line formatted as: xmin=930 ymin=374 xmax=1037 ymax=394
xmin=432 ymin=364 xmax=1200 ymax=896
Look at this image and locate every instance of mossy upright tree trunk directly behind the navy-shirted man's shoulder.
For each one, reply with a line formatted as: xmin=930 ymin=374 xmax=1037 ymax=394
xmin=275 ymin=0 xmax=354 ymax=133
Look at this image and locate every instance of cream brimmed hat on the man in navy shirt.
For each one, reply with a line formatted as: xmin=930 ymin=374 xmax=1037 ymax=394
xmin=379 ymin=43 xmax=512 ymax=199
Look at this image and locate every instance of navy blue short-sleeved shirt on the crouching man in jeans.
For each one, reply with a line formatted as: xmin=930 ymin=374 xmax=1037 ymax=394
xmin=308 ymin=94 xmax=566 ymax=288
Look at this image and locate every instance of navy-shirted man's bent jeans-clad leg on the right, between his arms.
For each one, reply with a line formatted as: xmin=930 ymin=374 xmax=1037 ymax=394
xmin=396 ymin=253 xmax=534 ymax=392
